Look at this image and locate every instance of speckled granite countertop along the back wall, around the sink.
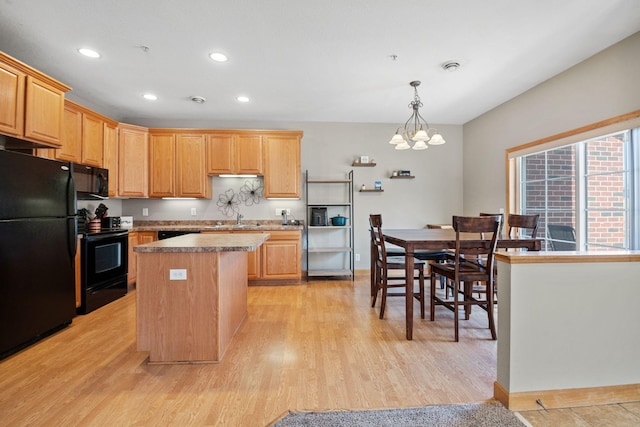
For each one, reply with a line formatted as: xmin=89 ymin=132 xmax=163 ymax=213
xmin=128 ymin=220 xmax=304 ymax=231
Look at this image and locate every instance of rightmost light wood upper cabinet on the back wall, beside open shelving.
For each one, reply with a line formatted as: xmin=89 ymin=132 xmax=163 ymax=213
xmin=263 ymin=131 xmax=302 ymax=199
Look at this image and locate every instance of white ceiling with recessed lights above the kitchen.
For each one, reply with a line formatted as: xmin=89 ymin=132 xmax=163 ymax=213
xmin=0 ymin=0 xmax=640 ymax=124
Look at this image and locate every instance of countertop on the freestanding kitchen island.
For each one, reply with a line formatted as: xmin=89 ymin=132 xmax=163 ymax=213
xmin=133 ymin=233 xmax=269 ymax=253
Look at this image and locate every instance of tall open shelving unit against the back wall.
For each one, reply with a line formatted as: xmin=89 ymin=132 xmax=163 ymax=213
xmin=305 ymin=170 xmax=355 ymax=280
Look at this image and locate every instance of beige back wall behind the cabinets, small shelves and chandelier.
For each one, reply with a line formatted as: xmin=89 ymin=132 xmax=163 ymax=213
xmin=117 ymin=119 xmax=462 ymax=269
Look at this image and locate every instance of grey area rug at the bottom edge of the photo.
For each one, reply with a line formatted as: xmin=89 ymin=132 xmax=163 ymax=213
xmin=270 ymin=403 xmax=527 ymax=427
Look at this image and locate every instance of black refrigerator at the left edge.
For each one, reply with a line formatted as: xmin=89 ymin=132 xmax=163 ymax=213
xmin=0 ymin=150 xmax=77 ymax=359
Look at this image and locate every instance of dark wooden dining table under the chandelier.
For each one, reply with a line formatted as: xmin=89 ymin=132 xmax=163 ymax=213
xmin=382 ymin=228 xmax=542 ymax=340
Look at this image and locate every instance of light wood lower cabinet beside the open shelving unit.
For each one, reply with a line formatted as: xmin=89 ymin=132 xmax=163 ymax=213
xmin=202 ymin=230 xmax=302 ymax=283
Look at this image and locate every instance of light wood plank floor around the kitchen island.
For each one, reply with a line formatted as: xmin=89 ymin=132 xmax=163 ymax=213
xmin=0 ymin=275 xmax=640 ymax=426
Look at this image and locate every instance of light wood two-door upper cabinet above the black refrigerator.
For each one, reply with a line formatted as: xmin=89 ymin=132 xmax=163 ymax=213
xmin=0 ymin=52 xmax=71 ymax=148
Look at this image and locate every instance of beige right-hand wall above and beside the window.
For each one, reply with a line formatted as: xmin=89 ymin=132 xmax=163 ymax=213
xmin=463 ymin=33 xmax=640 ymax=215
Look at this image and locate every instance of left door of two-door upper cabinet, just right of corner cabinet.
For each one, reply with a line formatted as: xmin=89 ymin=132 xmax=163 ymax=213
xmin=149 ymin=134 xmax=176 ymax=197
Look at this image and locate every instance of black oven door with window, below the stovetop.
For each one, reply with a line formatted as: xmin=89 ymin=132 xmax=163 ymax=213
xmin=82 ymin=231 xmax=129 ymax=290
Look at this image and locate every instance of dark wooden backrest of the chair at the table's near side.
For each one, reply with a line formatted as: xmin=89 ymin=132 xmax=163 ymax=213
xmin=453 ymin=215 xmax=502 ymax=274
